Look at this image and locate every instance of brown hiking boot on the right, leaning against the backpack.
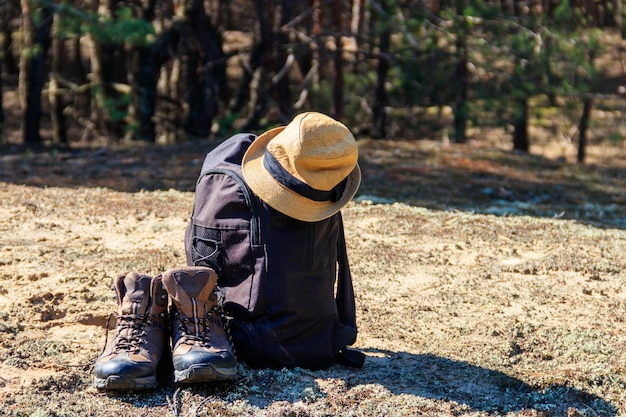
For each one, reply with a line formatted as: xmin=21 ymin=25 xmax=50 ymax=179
xmin=163 ymin=266 xmax=237 ymax=383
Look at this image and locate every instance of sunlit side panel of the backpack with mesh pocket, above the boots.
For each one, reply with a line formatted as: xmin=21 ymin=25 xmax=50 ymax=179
xmin=185 ymin=168 xmax=265 ymax=316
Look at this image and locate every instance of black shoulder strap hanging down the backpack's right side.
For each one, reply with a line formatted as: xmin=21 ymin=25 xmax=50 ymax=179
xmin=335 ymin=213 xmax=365 ymax=368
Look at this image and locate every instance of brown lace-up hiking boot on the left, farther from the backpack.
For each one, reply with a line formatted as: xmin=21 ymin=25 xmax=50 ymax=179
xmin=94 ymin=272 xmax=168 ymax=390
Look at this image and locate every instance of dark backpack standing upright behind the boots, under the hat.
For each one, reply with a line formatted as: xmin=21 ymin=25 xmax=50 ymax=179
xmin=185 ymin=133 xmax=365 ymax=369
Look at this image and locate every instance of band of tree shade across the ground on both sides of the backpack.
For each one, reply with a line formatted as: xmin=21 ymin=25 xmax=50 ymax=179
xmin=0 ymin=140 xmax=626 ymax=229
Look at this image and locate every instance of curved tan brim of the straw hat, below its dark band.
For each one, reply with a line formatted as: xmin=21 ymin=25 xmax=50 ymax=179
xmin=241 ymin=126 xmax=361 ymax=222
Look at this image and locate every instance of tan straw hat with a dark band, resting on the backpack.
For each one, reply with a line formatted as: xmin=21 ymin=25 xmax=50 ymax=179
xmin=241 ymin=112 xmax=361 ymax=222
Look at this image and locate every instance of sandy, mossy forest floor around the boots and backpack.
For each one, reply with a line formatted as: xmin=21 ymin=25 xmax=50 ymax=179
xmin=0 ymin=124 xmax=626 ymax=417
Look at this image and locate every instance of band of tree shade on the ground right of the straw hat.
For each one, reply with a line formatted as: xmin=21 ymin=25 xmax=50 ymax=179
xmin=357 ymin=141 xmax=626 ymax=229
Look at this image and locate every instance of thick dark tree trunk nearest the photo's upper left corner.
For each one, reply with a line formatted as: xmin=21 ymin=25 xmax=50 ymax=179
xmin=20 ymin=0 xmax=53 ymax=147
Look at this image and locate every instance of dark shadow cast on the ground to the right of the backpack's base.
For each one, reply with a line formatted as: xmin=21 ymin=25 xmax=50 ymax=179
xmin=352 ymin=350 xmax=616 ymax=416
